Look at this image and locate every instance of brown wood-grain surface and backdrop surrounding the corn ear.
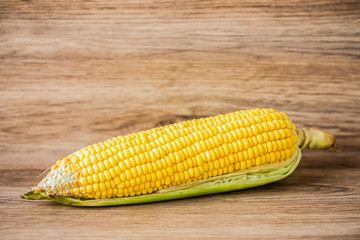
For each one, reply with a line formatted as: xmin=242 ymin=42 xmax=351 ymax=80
xmin=0 ymin=0 xmax=360 ymax=239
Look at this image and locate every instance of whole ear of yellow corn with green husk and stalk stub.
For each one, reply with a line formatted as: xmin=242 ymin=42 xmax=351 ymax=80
xmin=22 ymin=109 xmax=334 ymax=206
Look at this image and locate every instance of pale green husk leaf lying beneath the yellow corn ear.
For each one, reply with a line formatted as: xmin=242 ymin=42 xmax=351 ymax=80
xmin=25 ymin=149 xmax=301 ymax=207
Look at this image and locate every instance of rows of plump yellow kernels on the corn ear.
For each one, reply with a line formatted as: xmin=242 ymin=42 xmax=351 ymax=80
xmin=41 ymin=109 xmax=298 ymax=198
